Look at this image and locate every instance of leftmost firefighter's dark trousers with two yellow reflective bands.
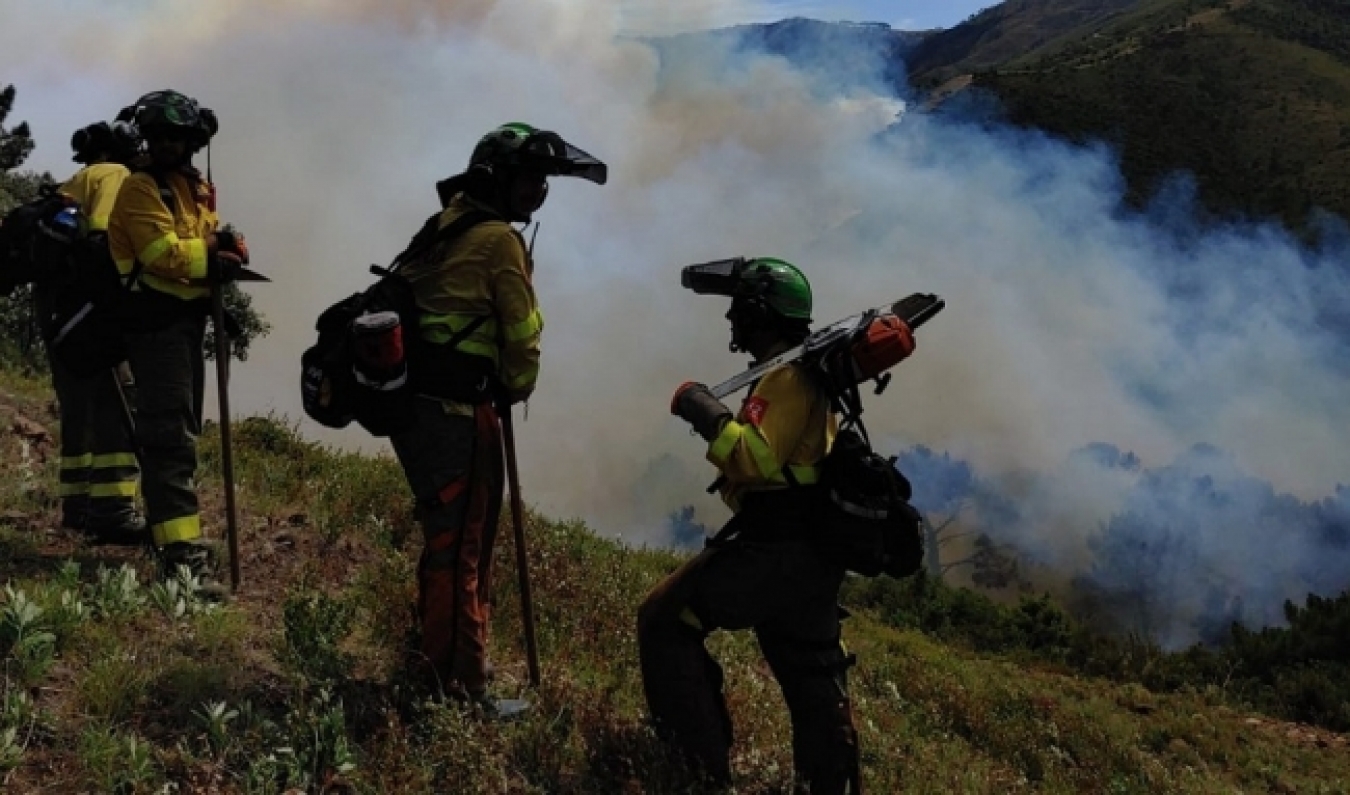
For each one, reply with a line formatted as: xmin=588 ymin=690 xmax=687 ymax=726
xmin=49 ymin=344 xmax=140 ymax=517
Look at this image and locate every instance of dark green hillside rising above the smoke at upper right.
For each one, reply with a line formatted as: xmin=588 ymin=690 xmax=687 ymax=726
xmin=915 ymin=0 xmax=1350 ymax=232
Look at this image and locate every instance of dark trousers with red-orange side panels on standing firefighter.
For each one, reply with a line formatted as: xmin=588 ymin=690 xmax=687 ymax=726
xmin=390 ymin=397 xmax=505 ymax=691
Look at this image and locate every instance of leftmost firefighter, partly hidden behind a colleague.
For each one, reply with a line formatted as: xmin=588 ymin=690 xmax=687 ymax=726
xmin=35 ymin=121 xmax=146 ymax=545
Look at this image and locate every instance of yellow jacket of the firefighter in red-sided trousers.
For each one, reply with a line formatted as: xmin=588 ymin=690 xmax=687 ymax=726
xmin=400 ymin=194 xmax=544 ymax=400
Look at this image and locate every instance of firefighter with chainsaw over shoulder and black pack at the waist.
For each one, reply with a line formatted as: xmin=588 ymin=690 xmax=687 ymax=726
xmin=637 ymin=258 xmax=941 ymax=795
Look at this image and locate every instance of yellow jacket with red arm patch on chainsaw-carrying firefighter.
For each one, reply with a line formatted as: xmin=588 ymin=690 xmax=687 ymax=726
xmin=707 ymin=364 xmax=838 ymax=510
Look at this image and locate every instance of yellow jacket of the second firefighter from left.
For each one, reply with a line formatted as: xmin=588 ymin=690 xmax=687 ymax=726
xmin=108 ymin=170 xmax=219 ymax=301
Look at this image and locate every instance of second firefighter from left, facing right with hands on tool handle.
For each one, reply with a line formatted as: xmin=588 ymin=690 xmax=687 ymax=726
xmin=108 ymin=90 xmax=248 ymax=598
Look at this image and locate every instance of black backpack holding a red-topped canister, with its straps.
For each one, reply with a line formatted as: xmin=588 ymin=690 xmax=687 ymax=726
xmin=300 ymin=212 xmax=495 ymax=436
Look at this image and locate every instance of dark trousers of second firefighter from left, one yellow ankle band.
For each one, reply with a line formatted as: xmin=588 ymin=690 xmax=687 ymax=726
xmin=127 ymin=314 xmax=207 ymax=547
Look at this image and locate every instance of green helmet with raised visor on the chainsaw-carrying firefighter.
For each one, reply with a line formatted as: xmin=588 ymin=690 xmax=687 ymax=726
xmin=680 ymin=256 xmax=811 ymax=323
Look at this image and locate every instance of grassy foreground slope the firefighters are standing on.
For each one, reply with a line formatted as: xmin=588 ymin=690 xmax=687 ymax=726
xmin=0 ymin=374 xmax=1350 ymax=794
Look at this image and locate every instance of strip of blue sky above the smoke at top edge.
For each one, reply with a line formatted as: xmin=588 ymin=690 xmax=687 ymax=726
xmin=620 ymin=0 xmax=998 ymax=34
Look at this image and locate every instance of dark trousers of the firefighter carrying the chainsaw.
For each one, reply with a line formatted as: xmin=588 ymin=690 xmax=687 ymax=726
xmin=637 ymin=534 xmax=857 ymax=795
